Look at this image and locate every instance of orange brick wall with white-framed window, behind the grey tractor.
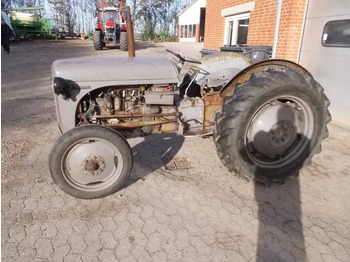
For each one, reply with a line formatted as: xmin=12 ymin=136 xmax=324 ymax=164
xmin=204 ymin=0 xmax=307 ymax=61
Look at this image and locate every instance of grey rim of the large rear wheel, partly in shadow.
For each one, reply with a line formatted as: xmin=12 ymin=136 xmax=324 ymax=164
xmin=245 ymin=96 xmax=315 ymax=168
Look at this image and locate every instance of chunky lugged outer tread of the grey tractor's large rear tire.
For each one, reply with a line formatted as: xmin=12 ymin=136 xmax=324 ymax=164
xmin=214 ymin=68 xmax=331 ymax=180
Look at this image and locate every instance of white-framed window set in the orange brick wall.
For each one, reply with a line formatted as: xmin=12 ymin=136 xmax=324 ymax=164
xmin=224 ymin=13 xmax=249 ymax=45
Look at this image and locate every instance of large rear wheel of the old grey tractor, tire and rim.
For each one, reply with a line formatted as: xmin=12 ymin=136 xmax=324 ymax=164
xmin=214 ymin=68 xmax=331 ymax=182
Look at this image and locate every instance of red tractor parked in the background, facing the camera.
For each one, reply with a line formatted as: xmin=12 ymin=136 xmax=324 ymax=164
xmin=94 ymin=1 xmax=128 ymax=51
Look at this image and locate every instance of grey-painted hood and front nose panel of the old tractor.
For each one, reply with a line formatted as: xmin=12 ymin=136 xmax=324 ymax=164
xmin=51 ymin=57 xmax=179 ymax=133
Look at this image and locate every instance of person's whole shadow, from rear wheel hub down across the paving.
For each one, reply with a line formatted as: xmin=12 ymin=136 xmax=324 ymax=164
xmin=250 ymin=109 xmax=311 ymax=262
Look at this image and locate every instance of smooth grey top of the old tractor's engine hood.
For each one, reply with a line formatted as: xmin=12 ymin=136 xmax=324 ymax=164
xmin=51 ymin=57 xmax=180 ymax=85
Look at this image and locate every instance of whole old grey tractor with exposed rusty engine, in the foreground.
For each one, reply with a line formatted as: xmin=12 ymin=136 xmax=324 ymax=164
xmin=49 ymin=50 xmax=331 ymax=198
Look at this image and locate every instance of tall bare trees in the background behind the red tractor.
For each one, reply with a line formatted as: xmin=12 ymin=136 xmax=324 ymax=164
xmin=1 ymin=0 xmax=191 ymax=41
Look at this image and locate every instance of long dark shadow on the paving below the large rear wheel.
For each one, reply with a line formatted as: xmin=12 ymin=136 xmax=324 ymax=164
xmin=254 ymin=177 xmax=306 ymax=262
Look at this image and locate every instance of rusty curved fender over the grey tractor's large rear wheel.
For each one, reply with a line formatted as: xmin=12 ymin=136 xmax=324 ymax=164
xmin=220 ymin=59 xmax=312 ymax=98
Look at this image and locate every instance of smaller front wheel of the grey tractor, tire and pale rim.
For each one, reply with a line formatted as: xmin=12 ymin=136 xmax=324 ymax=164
xmin=49 ymin=125 xmax=132 ymax=199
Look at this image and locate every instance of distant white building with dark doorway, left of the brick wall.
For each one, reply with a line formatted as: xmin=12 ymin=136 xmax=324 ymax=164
xmin=177 ymin=0 xmax=206 ymax=42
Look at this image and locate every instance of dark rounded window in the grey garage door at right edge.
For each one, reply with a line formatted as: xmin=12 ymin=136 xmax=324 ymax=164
xmin=322 ymin=19 xmax=350 ymax=47
